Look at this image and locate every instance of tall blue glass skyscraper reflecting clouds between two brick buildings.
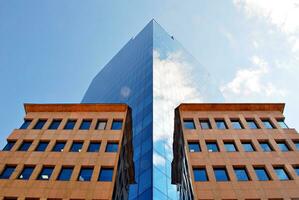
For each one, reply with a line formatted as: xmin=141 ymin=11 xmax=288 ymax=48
xmin=82 ymin=20 xmax=223 ymax=200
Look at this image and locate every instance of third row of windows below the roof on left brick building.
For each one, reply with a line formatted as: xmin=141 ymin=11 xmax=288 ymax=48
xmin=0 ymin=165 xmax=113 ymax=181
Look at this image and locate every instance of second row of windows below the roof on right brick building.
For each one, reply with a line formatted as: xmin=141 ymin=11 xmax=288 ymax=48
xmin=188 ymin=140 xmax=299 ymax=152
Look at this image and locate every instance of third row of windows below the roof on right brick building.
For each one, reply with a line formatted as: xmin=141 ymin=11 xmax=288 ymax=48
xmin=193 ymin=165 xmax=299 ymax=182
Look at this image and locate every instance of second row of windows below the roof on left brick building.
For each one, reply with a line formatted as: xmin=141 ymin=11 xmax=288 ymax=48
xmin=3 ymin=141 xmax=118 ymax=152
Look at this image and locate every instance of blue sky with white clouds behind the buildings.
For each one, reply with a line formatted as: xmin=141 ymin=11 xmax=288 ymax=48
xmin=0 ymin=0 xmax=299 ymax=146
